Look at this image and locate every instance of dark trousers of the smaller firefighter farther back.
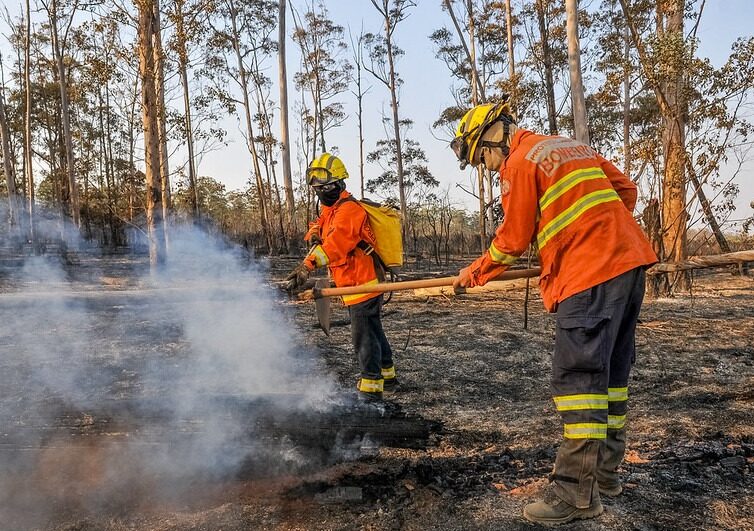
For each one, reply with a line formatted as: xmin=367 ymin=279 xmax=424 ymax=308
xmin=348 ymin=295 xmax=393 ymax=380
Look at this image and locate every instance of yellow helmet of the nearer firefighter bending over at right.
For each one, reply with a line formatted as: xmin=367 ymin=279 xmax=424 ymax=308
xmin=450 ymin=98 xmax=516 ymax=169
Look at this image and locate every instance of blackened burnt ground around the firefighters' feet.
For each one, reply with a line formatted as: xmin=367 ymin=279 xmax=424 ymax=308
xmin=0 ymin=255 xmax=754 ymax=531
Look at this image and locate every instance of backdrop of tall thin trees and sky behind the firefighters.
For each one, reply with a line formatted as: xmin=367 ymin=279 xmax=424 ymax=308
xmin=0 ymin=0 xmax=754 ymax=296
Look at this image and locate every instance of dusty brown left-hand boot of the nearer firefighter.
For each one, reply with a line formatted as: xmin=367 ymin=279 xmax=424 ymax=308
xmin=524 ymin=439 xmax=604 ymax=526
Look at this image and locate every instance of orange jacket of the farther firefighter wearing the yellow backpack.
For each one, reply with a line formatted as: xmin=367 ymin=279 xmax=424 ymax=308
xmin=304 ymin=190 xmax=380 ymax=306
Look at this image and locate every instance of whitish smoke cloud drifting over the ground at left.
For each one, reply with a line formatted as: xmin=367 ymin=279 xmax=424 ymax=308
xmin=0 ymin=219 xmax=335 ymax=528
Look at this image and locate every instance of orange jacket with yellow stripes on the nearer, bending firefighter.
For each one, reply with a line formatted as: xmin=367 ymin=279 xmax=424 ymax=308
xmin=469 ymin=129 xmax=657 ymax=312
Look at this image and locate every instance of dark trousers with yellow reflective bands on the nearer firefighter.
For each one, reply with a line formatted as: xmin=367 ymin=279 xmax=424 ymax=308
xmin=552 ymin=268 xmax=645 ymax=507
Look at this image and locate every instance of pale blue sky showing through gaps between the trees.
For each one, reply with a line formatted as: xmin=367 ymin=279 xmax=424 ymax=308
xmin=0 ymin=0 xmax=754 ymax=224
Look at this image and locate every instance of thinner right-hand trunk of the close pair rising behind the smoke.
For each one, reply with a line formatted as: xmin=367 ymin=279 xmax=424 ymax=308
xmin=152 ymin=0 xmax=171 ymax=246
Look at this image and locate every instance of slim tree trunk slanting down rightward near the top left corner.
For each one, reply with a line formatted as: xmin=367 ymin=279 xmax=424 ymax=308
xmin=49 ymin=0 xmax=81 ymax=228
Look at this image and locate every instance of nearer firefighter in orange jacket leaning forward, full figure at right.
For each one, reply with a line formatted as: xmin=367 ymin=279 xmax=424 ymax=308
xmin=451 ymin=102 xmax=657 ymax=525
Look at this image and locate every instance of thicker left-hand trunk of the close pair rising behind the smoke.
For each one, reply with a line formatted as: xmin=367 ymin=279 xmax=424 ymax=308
xmin=137 ymin=0 xmax=166 ymax=271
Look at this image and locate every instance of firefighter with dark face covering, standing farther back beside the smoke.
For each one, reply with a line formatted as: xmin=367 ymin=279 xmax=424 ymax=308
xmin=286 ymin=153 xmax=397 ymax=400
